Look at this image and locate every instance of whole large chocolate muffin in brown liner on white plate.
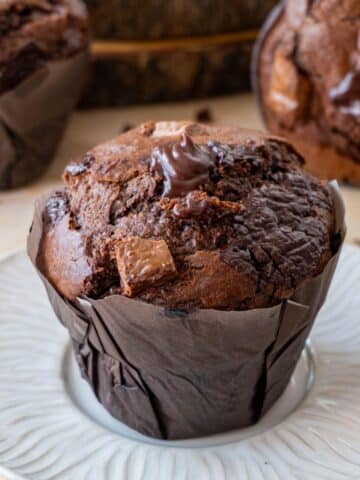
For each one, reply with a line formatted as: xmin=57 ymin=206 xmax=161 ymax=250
xmin=28 ymin=122 xmax=344 ymax=439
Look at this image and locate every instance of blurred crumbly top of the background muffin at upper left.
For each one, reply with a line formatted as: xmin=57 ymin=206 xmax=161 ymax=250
xmin=0 ymin=0 xmax=89 ymax=94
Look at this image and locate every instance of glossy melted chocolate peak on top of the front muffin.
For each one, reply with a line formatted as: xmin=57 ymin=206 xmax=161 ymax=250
xmin=151 ymin=134 xmax=215 ymax=197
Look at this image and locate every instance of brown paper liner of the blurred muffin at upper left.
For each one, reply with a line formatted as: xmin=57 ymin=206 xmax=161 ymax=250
xmin=0 ymin=51 xmax=88 ymax=190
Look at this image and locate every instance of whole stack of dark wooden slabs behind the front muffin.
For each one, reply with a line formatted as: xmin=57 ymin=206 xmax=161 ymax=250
xmin=81 ymin=0 xmax=277 ymax=108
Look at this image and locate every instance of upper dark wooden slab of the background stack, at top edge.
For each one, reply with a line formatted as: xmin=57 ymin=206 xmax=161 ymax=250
xmin=86 ymin=0 xmax=277 ymax=40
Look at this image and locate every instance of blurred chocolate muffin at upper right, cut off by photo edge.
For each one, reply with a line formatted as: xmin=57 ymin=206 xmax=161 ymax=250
xmin=253 ymin=0 xmax=360 ymax=184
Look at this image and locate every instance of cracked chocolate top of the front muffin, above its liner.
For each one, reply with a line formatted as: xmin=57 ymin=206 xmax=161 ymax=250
xmin=39 ymin=122 xmax=335 ymax=310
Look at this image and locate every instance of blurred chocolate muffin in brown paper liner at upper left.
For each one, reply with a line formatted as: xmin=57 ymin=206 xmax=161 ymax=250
xmin=0 ymin=0 xmax=89 ymax=189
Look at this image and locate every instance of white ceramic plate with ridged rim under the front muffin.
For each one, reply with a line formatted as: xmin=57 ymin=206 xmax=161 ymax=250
xmin=0 ymin=246 xmax=360 ymax=480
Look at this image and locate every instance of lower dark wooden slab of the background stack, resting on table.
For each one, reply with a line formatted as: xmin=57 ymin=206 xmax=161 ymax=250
xmin=81 ymin=30 xmax=257 ymax=108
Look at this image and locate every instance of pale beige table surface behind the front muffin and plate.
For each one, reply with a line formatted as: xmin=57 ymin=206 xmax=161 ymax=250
xmin=0 ymin=94 xmax=360 ymax=256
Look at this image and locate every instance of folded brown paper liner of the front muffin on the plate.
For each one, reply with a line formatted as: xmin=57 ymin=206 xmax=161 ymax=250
xmin=28 ymin=183 xmax=345 ymax=439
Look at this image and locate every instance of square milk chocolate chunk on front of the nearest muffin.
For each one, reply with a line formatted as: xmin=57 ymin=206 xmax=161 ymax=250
xmin=115 ymin=237 xmax=176 ymax=297
